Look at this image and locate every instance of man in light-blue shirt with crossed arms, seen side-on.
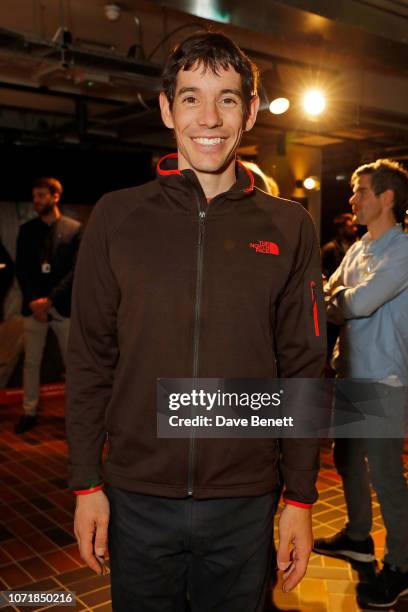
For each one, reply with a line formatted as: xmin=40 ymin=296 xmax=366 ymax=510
xmin=314 ymin=159 xmax=408 ymax=607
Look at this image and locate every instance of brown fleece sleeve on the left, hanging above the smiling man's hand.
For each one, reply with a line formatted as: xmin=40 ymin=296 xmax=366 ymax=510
xmin=66 ymin=197 xmax=120 ymax=491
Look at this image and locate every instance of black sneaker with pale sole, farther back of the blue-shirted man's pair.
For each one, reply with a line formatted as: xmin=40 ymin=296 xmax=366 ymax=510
xmin=313 ymin=529 xmax=375 ymax=563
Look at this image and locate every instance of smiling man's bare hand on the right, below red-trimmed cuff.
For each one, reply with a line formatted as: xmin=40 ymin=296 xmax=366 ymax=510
xmin=277 ymin=504 xmax=313 ymax=591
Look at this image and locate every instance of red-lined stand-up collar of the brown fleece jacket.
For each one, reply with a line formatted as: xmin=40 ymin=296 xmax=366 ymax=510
xmin=156 ymin=153 xmax=254 ymax=200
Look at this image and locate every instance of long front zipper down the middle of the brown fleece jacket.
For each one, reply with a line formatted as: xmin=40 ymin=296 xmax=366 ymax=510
xmin=187 ymin=206 xmax=206 ymax=495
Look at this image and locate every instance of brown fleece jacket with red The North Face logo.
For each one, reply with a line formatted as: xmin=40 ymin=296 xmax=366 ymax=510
xmin=66 ymin=155 xmax=326 ymax=504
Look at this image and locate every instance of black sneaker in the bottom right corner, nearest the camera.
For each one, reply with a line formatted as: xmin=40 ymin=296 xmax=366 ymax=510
xmin=357 ymin=563 xmax=408 ymax=608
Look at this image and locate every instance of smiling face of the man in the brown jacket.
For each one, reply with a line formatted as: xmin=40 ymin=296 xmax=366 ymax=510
xmin=160 ymin=64 xmax=259 ymax=174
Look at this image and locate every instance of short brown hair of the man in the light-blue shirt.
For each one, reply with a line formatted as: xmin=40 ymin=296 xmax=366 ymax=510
xmin=350 ymin=159 xmax=408 ymax=223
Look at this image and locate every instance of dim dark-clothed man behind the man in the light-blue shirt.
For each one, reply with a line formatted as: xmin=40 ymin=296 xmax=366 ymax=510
xmin=322 ymin=213 xmax=357 ymax=278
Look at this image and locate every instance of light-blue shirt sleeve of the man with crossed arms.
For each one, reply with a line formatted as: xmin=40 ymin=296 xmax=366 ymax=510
xmin=336 ymin=249 xmax=408 ymax=319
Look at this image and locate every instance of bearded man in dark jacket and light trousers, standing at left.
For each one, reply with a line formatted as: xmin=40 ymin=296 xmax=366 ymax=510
xmin=15 ymin=178 xmax=81 ymax=434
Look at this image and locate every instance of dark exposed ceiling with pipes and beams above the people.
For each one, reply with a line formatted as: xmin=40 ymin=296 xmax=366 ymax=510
xmin=0 ymin=0 xmax=408 ymax=169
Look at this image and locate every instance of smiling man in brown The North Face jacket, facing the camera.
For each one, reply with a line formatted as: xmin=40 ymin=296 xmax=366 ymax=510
xmin=67 ymin=33 xmax=325 ymax=612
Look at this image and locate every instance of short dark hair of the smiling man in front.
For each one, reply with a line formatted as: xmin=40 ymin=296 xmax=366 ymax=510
xmin=162 ymin=32 xmax=259 ymax=120
